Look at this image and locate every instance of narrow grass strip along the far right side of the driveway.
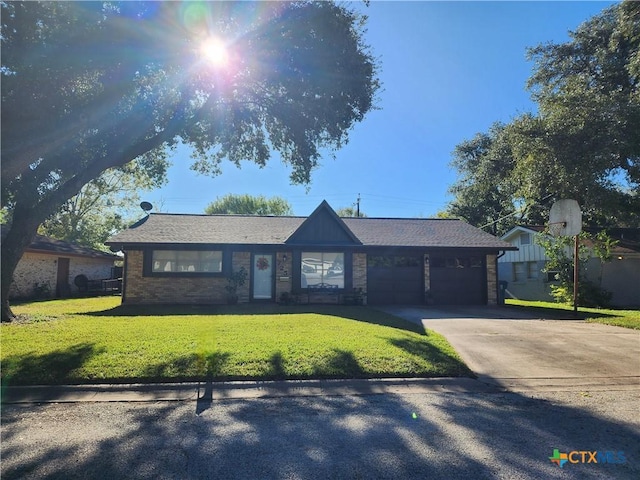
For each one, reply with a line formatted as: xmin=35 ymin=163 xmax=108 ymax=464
xmin=505 ymin=299 xmax=640 ymax=330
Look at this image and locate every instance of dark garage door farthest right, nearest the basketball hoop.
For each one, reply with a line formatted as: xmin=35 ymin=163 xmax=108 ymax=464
xmin=430 ymin=256 xmax=486 ymax=305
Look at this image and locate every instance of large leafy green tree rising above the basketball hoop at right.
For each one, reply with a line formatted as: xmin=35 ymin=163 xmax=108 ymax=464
xmin=448 ymin=2 xmax=640 ymax=234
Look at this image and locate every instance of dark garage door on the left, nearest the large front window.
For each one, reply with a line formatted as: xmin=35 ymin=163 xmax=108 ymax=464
xmin=367 ymin=255 xmax=424 ymax=305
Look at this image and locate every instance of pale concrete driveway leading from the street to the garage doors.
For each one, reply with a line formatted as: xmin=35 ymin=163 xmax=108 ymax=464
xmin=384 ymin=306 xmax=640 ymax=391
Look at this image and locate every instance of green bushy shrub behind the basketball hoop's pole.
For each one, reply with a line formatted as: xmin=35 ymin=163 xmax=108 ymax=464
xmin=536 ymin=231 xmax=616 ymax=307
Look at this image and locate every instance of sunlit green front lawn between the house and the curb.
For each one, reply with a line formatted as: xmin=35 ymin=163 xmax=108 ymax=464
xmin=0 ymin=297 xmax=470 ymax=385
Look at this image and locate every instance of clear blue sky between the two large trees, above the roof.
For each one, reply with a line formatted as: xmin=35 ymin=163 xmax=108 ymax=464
xmin=143 ymin=1 xmax=612 ymax=217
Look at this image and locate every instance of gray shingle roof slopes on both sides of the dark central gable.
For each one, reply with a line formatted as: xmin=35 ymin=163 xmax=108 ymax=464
xmin=107 ymin=213 xmax=513 ymax=250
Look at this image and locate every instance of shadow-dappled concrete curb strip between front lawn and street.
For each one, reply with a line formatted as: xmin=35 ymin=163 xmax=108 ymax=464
xmin=2 ymin=377 xmax=504 ymax=404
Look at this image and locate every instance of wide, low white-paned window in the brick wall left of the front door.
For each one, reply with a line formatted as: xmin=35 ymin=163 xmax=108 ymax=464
xmin=151 ymin=250 xmax=222 ymax=273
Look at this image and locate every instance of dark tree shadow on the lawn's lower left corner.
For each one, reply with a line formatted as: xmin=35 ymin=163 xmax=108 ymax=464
xmin=2 ymin=343 xmax=104 ymax=386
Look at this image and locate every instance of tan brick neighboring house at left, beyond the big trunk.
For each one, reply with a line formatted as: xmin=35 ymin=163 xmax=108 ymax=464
xmin=2 ymin=226 xmax=120 ymax=298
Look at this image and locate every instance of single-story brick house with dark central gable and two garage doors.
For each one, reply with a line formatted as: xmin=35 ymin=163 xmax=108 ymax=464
xmin=107 ymin=201 xmax=514 ymax=304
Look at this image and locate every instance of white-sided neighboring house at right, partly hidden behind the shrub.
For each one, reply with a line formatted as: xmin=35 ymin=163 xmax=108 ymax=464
xmin=498 ymin=226 xmax=640 ymax=307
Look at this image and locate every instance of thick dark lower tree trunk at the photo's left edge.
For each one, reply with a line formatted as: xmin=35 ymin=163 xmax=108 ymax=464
xmin=0 ymin=206 xmax=45 ymax=322
